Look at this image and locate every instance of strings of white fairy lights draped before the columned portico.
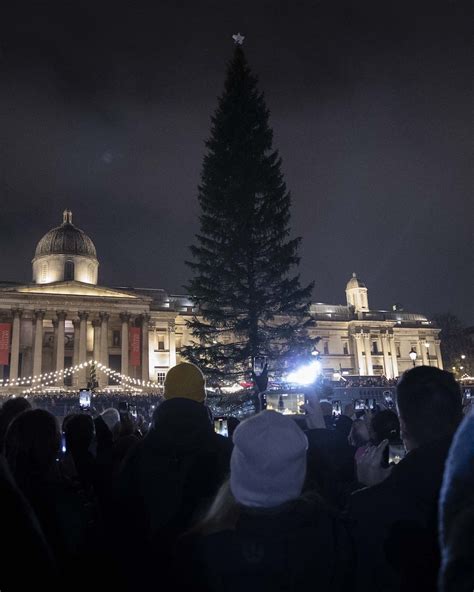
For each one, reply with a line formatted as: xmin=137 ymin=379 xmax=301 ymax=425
xmin=0 ymin=360 xmax=160 ymax=394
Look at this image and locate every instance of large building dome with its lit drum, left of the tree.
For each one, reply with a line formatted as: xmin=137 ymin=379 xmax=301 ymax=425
xmin=33 ymin=210 xmax=99 ymax=284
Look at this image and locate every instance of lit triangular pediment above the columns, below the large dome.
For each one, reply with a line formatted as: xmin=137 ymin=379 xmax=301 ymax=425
xmin=0 ymin=281 xmax=148 ymax=301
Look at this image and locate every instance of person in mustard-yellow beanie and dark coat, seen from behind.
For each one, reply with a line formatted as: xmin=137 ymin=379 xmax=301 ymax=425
xmin=114 ymin=363 xmax=232 ymax=589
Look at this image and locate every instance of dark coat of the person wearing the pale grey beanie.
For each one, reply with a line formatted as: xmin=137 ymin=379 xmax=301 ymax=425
xmin=178 ymin=498 xmax=353 ymax=592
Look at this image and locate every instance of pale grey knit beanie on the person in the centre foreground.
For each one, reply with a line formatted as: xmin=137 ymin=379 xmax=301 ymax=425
xmin=230 ymin=411 xmax=308 ymax=508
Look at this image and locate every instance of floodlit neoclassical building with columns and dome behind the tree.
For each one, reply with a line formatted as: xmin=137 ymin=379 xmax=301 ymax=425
xmin=0 ymin=210 xmax=442 ymax=388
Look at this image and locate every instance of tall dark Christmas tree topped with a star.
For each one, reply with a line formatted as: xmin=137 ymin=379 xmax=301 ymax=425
xmin=182 ymin=35 xmax=312 ymax=381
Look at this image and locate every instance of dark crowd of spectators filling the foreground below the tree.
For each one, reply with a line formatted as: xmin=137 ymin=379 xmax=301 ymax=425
xmin=0 ymin=363 xmax=474 ymax=592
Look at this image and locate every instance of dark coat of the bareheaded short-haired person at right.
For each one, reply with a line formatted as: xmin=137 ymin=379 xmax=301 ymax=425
xmin=349 ymin=437 xmax=451 ymax=592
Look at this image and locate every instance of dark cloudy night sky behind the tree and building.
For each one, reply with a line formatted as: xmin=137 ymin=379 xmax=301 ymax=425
xmin=0 ymin=0 xmax=474 ymax=323
